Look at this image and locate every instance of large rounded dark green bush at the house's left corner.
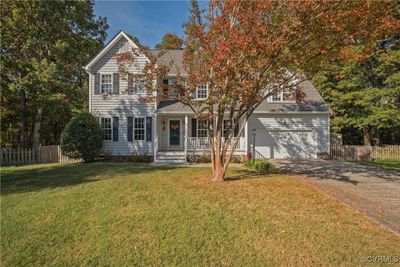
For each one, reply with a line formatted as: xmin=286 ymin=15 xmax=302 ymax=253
xmin=61 ymin=112 xmax=103 ymax=162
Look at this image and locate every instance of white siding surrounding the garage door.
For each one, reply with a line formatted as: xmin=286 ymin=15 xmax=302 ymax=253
xmin=248 ymin=113 xmax=330 ymax=159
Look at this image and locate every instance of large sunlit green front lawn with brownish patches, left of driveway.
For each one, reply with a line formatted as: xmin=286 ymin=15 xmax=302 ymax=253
xmin=1 ymin=163 xmax=400 ymax=266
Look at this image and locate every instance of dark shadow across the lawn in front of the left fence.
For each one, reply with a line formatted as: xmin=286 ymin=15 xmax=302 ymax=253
xmin=1 ymin=162 xmax=183 ymax=195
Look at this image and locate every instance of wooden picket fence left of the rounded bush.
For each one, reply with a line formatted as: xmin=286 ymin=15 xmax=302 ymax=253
xmin=0 ymin=145 xmax=81 ymax=166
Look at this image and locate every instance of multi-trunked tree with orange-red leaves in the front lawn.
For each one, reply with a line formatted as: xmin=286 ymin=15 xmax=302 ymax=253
xmin=117 ymin=0 xmax=400 ymax=181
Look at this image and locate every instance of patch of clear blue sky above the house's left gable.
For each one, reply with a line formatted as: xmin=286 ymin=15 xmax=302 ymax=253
xmin=94 ymin=1 xmax=194 ymax=47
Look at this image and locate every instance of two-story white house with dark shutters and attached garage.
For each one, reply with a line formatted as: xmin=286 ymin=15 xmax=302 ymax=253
xmin=85 ymin=31 xmax=330 ymax=162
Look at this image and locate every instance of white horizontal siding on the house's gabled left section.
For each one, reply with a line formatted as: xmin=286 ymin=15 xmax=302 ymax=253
xmin=89 ymin=37 xmax=155 ymax=155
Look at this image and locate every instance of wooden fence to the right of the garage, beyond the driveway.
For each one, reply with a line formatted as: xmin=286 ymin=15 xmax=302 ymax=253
xmin=330 ymin=145 xmax=400 ymax=161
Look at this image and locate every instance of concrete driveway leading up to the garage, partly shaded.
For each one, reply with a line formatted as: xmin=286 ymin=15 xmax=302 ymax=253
xmin=273 ymin=160 xmax=400 ymax=235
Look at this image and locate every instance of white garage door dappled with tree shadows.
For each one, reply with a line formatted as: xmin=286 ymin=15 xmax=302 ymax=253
xmin=256 ymin=129 xmax=317 ymax=159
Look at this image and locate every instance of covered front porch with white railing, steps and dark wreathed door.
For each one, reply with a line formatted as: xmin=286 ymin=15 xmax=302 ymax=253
xmin=153 ymin=114 xmax=247 ymax=162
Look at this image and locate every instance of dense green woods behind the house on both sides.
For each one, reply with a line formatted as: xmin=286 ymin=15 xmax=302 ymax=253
xmin=0 ymin=1 xmax=400 ymax=148
